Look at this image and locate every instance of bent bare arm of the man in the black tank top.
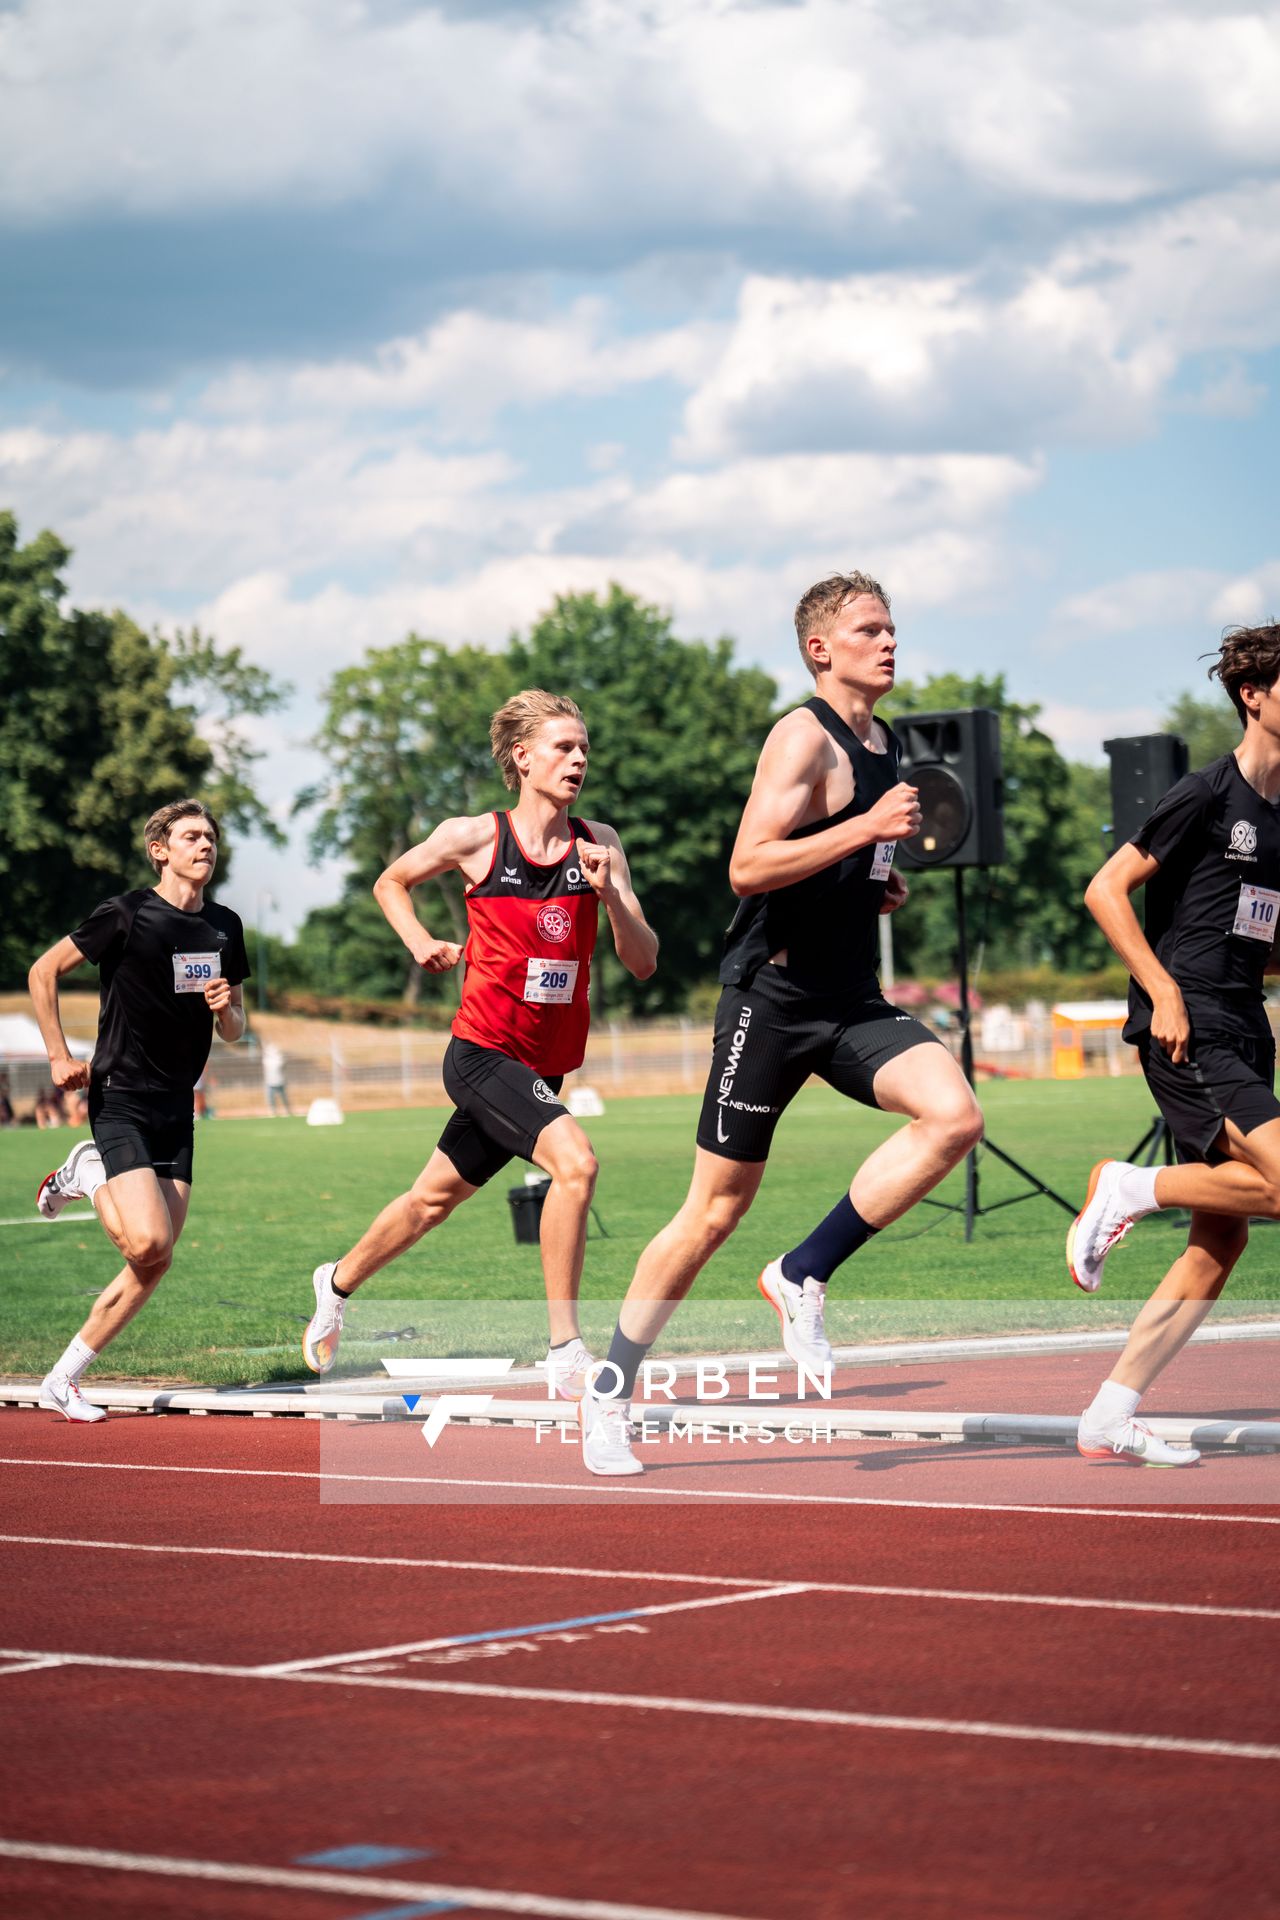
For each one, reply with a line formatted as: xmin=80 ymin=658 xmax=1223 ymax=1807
xmin=729 ymin=714 xmax=919 ymax=899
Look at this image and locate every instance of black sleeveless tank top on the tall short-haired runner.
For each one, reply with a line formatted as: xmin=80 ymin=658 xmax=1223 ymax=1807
xmin=720 ymin=695 xmax=902 ymax=993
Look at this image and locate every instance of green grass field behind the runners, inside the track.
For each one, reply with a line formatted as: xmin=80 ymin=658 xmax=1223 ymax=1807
xmin=0 ymin=1079 xmax=1280 ymax=1384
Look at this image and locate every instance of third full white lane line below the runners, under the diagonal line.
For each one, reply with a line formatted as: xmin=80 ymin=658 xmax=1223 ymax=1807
xmin=0 ymin=1647 xmax=1280 ymax=1761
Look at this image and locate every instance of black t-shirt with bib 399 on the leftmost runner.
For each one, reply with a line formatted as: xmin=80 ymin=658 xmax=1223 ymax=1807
xmin=71 ymin=887 xmax=249 ymax=1098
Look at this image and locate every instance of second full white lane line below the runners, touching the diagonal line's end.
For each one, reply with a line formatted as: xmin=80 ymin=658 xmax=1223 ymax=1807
xmin=0 ymin=1534 xmax=1280 ymax=1620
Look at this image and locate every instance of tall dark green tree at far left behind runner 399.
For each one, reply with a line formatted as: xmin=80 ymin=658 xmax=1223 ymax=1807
xmin=0 ymin=513 xmax=282 ymax=987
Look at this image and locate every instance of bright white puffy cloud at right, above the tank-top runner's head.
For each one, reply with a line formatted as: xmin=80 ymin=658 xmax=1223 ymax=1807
xmin=681 ymin=184 xmax=1280 ymax=459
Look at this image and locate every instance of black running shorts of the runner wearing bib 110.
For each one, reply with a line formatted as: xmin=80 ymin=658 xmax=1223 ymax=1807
xmin=1138 ymin=1025 xmax=1280 ymax=1167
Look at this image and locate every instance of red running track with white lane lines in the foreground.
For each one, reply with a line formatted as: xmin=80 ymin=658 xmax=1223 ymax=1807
xmin=0 ymin=1354 xmax=1280 ymax=1920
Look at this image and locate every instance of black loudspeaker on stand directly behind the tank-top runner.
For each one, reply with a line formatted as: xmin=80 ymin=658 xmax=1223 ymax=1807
xmin=892 ymin=707 xmax=1004 ymax=868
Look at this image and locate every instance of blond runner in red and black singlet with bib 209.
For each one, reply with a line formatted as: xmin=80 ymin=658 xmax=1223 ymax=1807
xmin=303 ymin=689 xmax=658 ymax=1400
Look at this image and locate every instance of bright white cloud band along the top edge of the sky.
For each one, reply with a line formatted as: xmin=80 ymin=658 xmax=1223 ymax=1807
xmin=0 ymin=0 xmax=1280 ymax=244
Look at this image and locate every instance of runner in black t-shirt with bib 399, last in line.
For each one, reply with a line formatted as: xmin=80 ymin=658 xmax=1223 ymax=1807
xmin=29 ymin=801 xmax=249 ymax=1421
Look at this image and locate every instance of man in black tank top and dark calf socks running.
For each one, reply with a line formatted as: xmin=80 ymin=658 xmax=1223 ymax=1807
xmin=583 ymin=574 xmax=983 ymax=1473
